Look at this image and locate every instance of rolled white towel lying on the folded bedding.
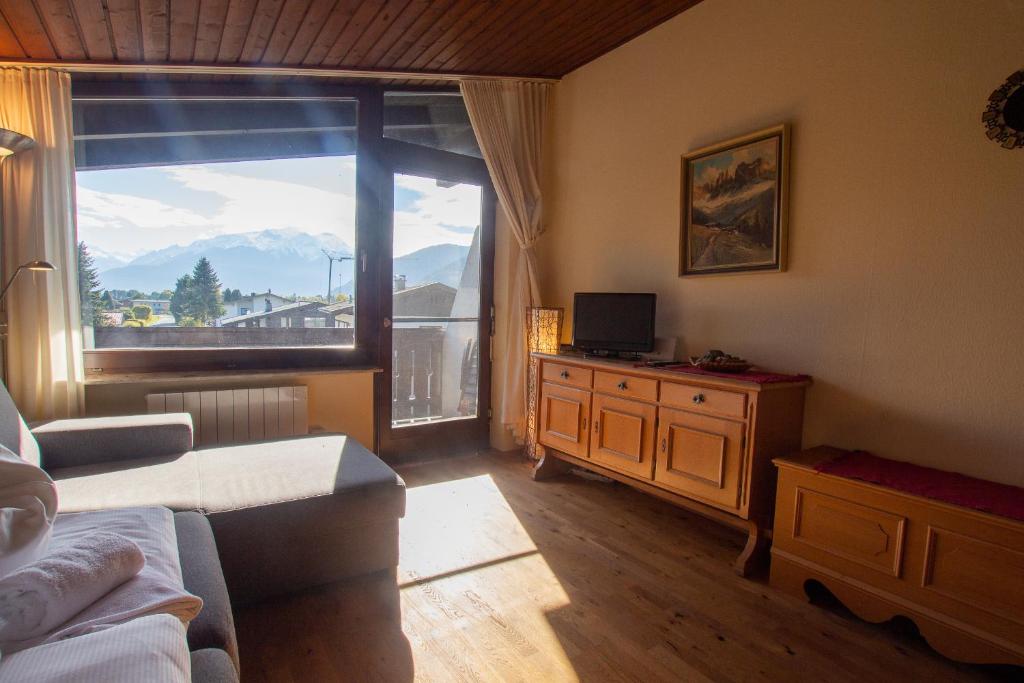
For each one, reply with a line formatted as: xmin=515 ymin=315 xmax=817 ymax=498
xmin=0 ymin=531 xmax=145 ymax=650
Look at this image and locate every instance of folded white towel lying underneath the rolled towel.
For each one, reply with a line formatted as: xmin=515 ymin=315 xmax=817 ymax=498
xmin=3 ymin=508 xmax=203 ymax=656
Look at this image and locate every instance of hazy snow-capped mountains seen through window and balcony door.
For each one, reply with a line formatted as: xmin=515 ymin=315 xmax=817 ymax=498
xmin=96 ymin=229 xmax=469 ymax=296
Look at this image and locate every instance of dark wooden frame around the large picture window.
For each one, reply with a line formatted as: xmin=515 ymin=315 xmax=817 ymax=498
xmin=72 ymin=79 xmax=401 ymax=374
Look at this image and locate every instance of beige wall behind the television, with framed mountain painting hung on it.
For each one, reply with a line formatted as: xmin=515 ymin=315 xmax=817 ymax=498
xmin=540 ymin=0 xmax=1024 ymax=484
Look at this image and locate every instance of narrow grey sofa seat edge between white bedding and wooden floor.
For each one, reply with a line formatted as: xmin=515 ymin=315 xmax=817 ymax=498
xmin=174 ymin=512 xmax=239 ymax=669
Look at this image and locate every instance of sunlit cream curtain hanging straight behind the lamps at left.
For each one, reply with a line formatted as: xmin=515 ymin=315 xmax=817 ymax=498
xmin=0 ymin=68 xmax=84 ymax=420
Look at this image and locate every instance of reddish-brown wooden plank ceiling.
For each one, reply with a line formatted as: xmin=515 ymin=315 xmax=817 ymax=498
xmin=0 ymin=0 xmax=699 ymax=78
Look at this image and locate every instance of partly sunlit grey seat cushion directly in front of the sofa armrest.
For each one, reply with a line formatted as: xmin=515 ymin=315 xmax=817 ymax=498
xmin=49 ymin=452 xmax=201 ymax=512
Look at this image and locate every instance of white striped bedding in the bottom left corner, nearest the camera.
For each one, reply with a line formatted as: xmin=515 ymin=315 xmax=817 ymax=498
xmin=0 ymin=614 xmax=191 ymax=683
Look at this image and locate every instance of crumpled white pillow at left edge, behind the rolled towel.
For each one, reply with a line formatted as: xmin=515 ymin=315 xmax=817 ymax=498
xmin=0 ymin=446 xmax=57 ymax=578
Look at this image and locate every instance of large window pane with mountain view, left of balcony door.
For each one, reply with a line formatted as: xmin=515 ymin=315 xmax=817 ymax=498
xmin=74 ymin=96 xmax=359 ymax=349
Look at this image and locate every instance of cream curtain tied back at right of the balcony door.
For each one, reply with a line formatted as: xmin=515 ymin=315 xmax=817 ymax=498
xmin=462 ymin=80 xmax=551 ymax=442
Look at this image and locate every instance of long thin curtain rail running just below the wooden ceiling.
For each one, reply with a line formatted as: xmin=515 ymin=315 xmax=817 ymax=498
xmin=0 ymin=58 xmax=559 ymax=83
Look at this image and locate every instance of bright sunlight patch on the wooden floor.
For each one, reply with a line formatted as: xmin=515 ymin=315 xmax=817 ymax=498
xmin=398 ymin=475 xmax=579 ymax=681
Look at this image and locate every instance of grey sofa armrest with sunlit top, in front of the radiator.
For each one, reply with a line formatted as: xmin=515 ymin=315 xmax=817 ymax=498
xmin=32 ymin=413 xmax=193 ymax=470
